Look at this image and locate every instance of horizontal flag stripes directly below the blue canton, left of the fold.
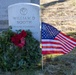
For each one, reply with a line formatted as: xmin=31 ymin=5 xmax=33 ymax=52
xmin=42 ymin=39 xmax=64 ymax=54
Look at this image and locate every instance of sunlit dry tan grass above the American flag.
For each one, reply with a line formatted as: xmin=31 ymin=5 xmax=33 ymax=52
xmin=41 ymin=0 xmax=76 ymax=33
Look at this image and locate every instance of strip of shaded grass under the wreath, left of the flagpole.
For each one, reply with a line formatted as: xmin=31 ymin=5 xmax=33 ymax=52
xmin=0 ymin=69 xmax=43 ymax=75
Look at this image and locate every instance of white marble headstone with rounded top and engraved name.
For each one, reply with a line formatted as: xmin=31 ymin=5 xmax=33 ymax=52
xmin=8 ymin=3 xmax=40 ymax=41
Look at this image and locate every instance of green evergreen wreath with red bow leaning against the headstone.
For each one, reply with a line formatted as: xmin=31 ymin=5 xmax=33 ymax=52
xmin=0 ymin=29 xmax=41 ymax=71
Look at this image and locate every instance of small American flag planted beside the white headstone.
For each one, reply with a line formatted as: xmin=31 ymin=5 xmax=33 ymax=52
xmin=41 ymin=22 xmax=76 ymax=54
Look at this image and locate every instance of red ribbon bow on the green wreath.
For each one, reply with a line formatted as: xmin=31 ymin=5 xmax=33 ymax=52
xmin=11 ymin=30 xmax=27 ymax=48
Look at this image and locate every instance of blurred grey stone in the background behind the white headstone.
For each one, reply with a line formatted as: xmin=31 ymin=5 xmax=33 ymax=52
xmin=0 ymin=0 xmax=31 ymax=31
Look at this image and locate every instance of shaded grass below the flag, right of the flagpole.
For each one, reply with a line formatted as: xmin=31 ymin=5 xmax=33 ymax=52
xmin=44 ymin=48 xmax=76 ymax=75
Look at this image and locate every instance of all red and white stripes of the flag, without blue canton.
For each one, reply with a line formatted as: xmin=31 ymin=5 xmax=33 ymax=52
xmin=41 ymin=32 xmax=76 ymax=54
